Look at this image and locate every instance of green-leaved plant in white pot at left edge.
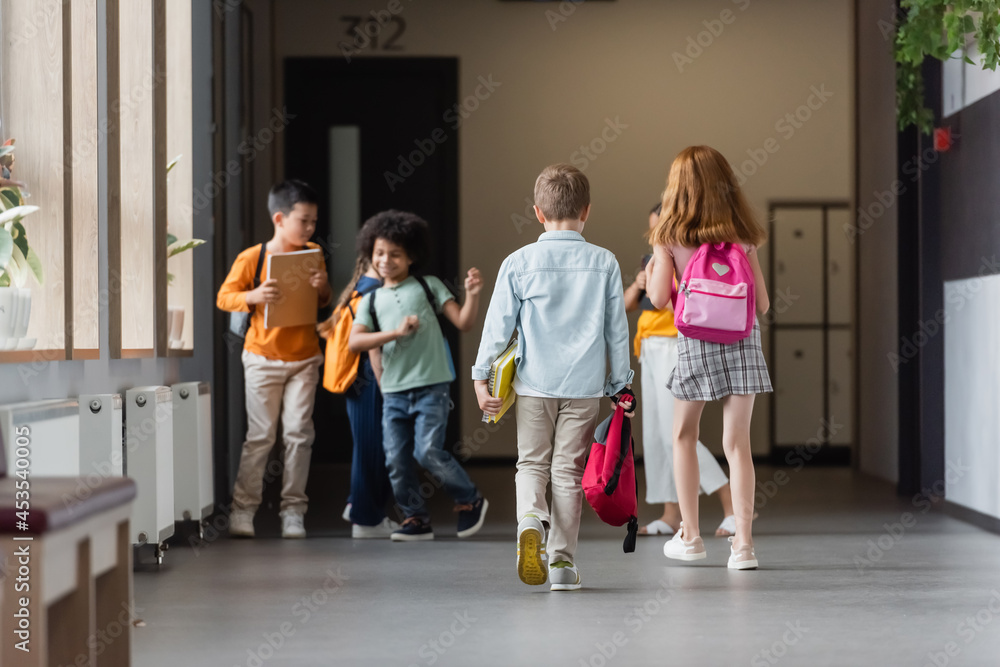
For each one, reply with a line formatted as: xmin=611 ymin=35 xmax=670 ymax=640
xmin=0 ymin=139 xmax=45 ymax=350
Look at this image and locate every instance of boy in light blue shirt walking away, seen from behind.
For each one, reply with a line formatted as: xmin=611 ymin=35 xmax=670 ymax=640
xmin=472 ymin=164 xmax=633 ymax=591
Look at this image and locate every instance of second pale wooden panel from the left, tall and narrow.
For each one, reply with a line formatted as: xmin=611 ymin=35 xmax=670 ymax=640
xmin=67 ymin=0 xmax=101 ymax=359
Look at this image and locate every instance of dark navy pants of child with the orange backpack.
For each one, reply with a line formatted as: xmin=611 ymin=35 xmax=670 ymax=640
xmin=345 ymin=354 xmax=389 ymax=526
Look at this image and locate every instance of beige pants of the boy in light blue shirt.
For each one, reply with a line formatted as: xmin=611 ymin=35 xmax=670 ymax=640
xmin=514 ymin=396 xmax=601 ymax=564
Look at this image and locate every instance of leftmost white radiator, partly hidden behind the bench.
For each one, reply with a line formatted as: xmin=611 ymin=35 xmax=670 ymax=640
xmin=0 ymin=398 xmax=81 ymax=477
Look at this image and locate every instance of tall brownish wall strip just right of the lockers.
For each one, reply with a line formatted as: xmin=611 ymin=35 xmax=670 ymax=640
xmin=857 ymin=0 xmax=899 ymax=482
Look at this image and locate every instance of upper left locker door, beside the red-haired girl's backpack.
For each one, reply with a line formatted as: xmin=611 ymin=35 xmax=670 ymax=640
xmin=768 ymin=208 xmax=823 ymax=324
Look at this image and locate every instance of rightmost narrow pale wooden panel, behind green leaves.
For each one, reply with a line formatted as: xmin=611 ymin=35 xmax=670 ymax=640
xmin=166 ymin=2 xmax=193 ymax=350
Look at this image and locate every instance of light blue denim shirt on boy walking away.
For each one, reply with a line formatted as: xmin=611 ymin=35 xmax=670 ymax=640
xmin=472 ymin=231 xmax=633 ymax=398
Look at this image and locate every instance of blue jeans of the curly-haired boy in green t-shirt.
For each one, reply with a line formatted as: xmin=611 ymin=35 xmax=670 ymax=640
xmin=382 ymin=382 xmax=479 ymax=519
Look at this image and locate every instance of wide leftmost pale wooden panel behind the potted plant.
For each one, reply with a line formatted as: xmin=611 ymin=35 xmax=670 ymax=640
xmin=0 ymin=0 xmax=66 ymax=359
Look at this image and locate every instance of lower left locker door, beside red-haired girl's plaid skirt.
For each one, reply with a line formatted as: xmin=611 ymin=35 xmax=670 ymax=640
xmin=772 ymin=330 xmax=825 ymax=446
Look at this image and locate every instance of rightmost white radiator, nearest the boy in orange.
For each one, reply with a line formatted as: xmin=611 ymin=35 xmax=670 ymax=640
xmin=171 ymin=382 xmax=215 ymax=521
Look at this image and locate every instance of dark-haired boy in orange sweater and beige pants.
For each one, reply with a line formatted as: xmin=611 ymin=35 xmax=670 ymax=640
xmin=216 ymin=181 xmax=333 ymax=538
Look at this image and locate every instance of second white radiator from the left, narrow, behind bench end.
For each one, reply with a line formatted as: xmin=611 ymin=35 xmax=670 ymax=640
xmin=80 ymin=394 xmax=125 ymax=479
